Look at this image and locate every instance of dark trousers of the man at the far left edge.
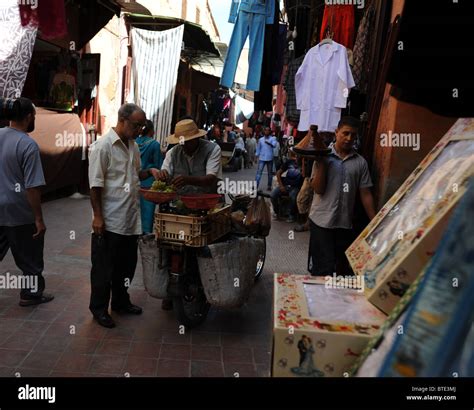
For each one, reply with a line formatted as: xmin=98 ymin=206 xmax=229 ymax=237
xmin=0 ymin=224 xmax=45 ymax=299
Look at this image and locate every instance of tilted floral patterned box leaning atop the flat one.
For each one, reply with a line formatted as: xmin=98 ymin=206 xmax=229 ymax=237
xmin=346 ymin=118 xmax=474 ymax=314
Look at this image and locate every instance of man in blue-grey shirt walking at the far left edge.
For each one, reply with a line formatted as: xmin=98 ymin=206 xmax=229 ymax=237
xmin=0 ymin=98 xmax=54 ymax=306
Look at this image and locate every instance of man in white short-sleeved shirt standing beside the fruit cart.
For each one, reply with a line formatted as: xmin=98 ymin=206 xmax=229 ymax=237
xmin=89 ymin=104 xmax=159 ymax=328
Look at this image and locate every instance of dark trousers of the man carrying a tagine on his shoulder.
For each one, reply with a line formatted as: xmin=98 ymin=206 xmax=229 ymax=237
xmin=309 ymin=220 xmax=354 ymax=276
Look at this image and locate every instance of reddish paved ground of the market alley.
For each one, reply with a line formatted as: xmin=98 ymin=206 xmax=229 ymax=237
xmin=0 ymin=164 xmax=309 ymax=377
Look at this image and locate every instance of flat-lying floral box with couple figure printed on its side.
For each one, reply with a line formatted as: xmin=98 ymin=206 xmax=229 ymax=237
xmin=272 ymin=273 xmax=386 ymax=377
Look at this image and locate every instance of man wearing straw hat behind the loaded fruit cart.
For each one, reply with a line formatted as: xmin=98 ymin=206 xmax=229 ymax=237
xmin=157 ymin=119 xmax=222 ymax=310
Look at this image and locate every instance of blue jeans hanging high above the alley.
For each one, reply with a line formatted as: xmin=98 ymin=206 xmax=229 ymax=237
xmin=221 ymin=11 xmax=265 ymax=91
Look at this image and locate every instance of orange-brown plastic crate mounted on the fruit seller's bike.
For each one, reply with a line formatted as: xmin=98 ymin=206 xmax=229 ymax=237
xmin=155 ymin=205 xmax=231 ymax=247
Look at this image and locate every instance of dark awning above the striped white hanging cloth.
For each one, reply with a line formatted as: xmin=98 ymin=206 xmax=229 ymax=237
xmin=125 ymin=13 xmax=220 ymax=58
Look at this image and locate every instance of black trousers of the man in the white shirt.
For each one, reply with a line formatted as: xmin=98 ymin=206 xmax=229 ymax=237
xmin=89 ymin=231 xmax=138 ymax=315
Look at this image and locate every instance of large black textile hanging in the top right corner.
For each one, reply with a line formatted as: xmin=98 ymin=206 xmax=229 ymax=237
xmin=387 ymin=0 xmax=474 ymax=118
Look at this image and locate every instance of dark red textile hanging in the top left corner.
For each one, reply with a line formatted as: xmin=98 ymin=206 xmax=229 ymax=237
xmin=17 ymin=0 xmax=68 ymax=40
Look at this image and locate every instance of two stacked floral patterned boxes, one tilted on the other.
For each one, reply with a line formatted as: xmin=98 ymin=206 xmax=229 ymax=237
xmin=272 ymin=118 xmax=474 ymax=377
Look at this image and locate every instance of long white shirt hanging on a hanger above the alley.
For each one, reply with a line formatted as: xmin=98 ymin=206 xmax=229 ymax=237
xmin=295 ymin=41 xmax=355 ymax=132
